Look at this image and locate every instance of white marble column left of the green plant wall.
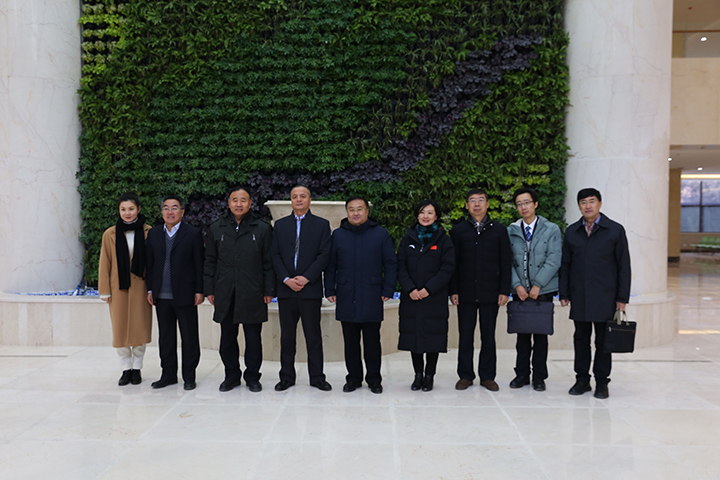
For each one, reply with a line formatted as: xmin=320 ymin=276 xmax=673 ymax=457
xmin=0 ymin=0 xmax=83 ymax=292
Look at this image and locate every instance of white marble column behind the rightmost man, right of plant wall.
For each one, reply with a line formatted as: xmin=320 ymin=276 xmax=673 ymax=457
xmin=565 ymin=0 xmax=675 ymax=343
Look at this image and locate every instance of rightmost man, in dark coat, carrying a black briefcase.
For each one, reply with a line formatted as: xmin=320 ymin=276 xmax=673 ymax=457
xmin=560 ymin=188 xmax=631 ymax=398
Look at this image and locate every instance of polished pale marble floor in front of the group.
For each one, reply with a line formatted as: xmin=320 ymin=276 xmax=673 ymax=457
xmin=0 ymin=255 xmax=720 ymax=480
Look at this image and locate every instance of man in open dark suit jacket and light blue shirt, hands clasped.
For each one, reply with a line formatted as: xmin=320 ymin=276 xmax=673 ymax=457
xmin=272 ymin=186 xmax=332 ymax=391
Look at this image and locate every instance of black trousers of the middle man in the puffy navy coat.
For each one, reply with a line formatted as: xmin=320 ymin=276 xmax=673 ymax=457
xmin=340 ymin=322 xmax=382 ymax=385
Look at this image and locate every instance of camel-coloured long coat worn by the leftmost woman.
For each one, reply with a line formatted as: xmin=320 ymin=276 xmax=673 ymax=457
xmin=98 ymin=225 xmax=152 ymax=348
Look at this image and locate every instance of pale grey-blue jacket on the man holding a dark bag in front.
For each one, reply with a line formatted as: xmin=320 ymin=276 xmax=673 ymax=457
xmin=508 ymin=215 xmax=562 ymax=295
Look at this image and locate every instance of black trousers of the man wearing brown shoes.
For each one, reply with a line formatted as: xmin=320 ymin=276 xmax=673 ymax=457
xmin=458 ymin=303 xmax=500 ymax=382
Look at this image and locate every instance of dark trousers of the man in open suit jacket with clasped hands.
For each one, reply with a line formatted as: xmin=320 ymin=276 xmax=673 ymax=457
xmin=278 ymin=298 xmax=325 ymax=383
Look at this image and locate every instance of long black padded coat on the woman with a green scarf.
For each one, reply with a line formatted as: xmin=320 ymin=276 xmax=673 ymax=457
xmin=398 ymin=227 xmax=455 ymax=353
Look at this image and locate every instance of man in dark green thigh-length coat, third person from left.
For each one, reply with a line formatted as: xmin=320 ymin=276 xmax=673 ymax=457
xmin=205 ymin=187 xmax=275 ymax=392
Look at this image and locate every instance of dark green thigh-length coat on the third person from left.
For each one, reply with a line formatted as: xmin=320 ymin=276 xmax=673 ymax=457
xmin=204 ymin=211 xmax=275 ymax=323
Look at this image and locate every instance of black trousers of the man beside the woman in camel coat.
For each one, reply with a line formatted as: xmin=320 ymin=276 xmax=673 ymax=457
xmin=155 ymin=299 xmax=200 ymax=383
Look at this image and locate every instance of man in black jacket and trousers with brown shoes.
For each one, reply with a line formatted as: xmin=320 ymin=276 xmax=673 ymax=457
xmin=450 ymin=189 xmax=512 ymax=392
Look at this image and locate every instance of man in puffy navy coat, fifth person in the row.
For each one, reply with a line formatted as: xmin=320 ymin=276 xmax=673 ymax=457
xmin=325 ymin=197 xmax=397 ymax=393
